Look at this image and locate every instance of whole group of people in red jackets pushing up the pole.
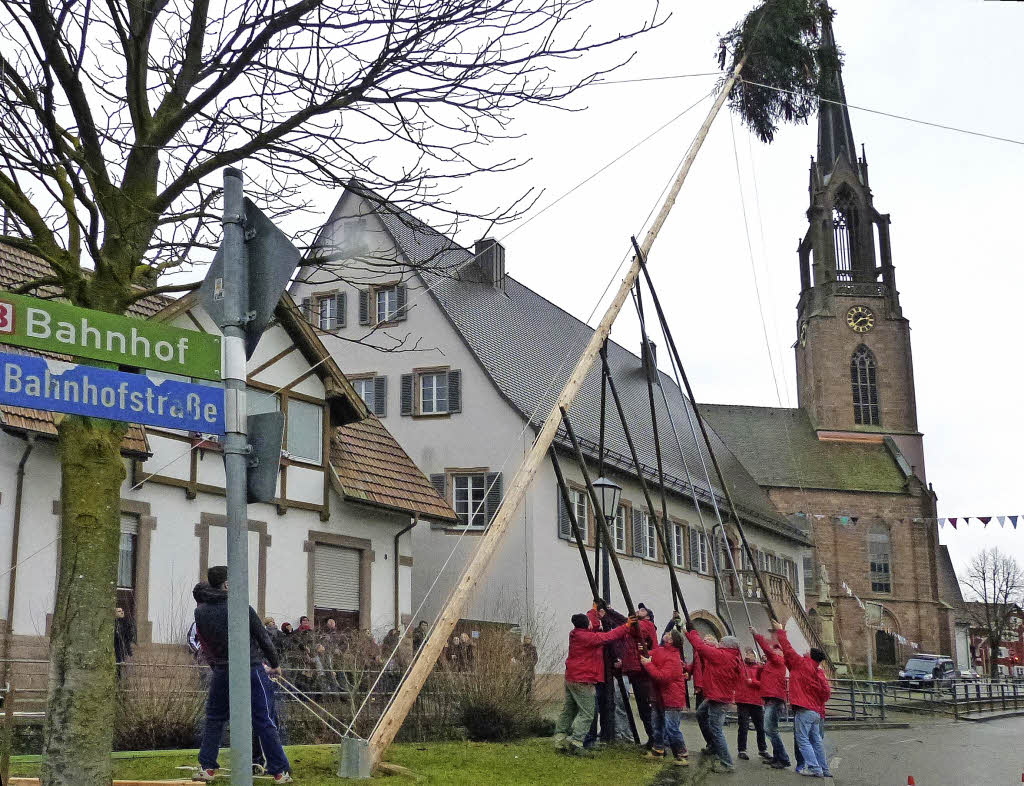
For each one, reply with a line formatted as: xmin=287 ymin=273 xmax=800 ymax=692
xmin=555 ymin=600 xmax=831 ymax=778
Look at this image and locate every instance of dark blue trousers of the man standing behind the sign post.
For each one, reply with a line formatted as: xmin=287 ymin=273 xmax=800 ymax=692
xmin=199 ymin=665 xmax=292 ymax=775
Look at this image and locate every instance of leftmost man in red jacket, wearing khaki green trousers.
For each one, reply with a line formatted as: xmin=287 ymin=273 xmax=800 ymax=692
xmin=555 ymin=614 xmax=636 ymax=753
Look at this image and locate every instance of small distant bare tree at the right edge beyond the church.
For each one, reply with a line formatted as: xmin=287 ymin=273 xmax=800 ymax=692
xmin=961 ymin=548 xmax=1024 ymax=680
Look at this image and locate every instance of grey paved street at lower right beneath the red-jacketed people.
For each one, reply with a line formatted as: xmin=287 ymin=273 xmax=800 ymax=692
xmin=654 ymin=717 xmax=1024 ymax=786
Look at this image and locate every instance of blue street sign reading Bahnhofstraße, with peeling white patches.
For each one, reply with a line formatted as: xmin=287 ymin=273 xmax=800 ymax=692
xmin=0 ymin=352 xmax=224 ymax=434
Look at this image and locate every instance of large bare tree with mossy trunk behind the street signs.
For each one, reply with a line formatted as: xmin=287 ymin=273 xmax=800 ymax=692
xmin=0 ymin=0 xmax=663 ymax=786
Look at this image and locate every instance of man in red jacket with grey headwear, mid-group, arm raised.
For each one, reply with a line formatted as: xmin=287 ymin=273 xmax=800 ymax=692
xmin=686 ymin=623 xmax=739 ymax=773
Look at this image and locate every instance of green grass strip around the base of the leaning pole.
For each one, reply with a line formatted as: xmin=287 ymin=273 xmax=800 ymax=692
xmin=11 ymin=739 xmax=660 ymax=786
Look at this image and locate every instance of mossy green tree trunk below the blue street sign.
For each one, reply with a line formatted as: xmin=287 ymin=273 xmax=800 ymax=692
xmin=42 ymin=416 xmax=127 ymax=786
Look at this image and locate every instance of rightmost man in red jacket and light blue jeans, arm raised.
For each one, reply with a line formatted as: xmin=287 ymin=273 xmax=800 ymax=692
xmin=772 ymin=620 xmax=831 ymax=778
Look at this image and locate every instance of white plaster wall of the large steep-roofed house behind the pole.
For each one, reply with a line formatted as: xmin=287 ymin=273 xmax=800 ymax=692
xmin=291 ymin=188 xmax=815 ymax=668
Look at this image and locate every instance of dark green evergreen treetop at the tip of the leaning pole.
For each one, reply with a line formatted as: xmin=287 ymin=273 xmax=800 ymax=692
xmin=718 ymin=0 xmax=842 ymax=142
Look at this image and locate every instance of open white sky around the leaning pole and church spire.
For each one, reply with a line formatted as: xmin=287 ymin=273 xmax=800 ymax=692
xmin=405 ymin=0 xmax=1024 ymax=567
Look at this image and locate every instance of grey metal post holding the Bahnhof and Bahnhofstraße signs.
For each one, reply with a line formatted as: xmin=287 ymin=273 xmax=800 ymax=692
xmin=221 ymin=168 xmax=253 ymax=786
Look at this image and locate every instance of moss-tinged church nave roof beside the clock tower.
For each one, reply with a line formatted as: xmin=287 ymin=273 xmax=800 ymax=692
xmin=699 ymin=404 xmax=906 ymax=493
